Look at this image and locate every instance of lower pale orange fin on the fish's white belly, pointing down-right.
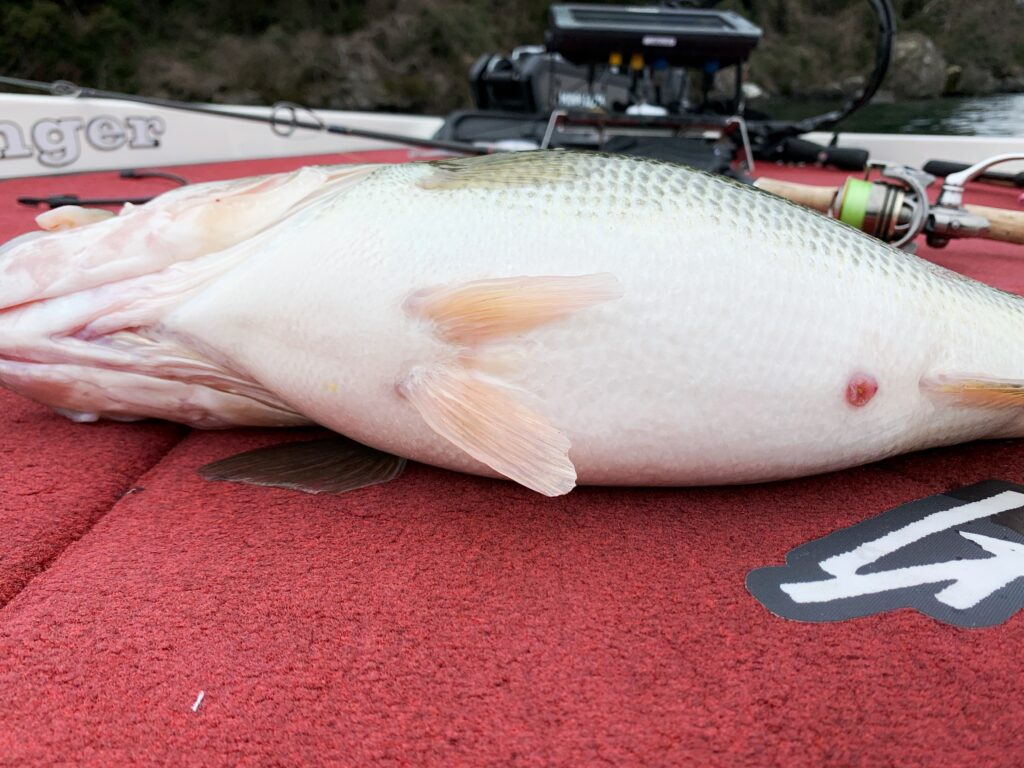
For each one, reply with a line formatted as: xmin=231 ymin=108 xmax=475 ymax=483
xmin=399 ymin=367 xmax=575 ymax=496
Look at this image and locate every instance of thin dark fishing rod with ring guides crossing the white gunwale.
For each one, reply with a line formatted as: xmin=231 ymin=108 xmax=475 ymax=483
xmin=0 ymin=75 xmax=494 ymax=155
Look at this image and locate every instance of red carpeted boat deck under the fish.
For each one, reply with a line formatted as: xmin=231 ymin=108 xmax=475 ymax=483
xmin=0 ymin=153 xmax=1024 ymax=767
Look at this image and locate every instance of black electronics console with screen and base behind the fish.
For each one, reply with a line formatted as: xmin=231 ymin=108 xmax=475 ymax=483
xmin=437 ymin=4 xmax=761 ymax=172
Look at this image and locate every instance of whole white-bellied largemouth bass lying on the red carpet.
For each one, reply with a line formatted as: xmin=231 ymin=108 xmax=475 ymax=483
xmin=0 ymin=152 xmax=1024 ymax=496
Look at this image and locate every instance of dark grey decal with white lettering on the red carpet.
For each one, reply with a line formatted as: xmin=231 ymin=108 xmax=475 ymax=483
xmin=746 ymin=480 xmax=1024 ymax=627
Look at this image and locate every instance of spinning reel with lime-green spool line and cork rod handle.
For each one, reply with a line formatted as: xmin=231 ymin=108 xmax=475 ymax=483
xmin=755 ymin=154 xmax=1024 ymax=250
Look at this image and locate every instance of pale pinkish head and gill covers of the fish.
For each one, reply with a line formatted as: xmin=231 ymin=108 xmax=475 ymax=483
xmin=0 ymin=167 xmax=374 ymax=427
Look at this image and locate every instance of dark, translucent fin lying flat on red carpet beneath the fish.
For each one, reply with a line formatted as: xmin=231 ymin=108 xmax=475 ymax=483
xmin=199 ymin=435 xmax=406 ymax=494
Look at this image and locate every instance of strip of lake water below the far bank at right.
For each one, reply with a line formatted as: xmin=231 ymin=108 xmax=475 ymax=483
xmin=757 ymin=93 xmax=1024 ymax=137
